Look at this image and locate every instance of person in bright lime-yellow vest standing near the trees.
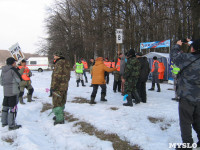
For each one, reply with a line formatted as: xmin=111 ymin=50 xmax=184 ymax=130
xmin=75 ymin=60 xmax=85 ymax=87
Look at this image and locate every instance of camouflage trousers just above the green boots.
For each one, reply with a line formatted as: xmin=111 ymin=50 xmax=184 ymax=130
xmin=53 ymin=91 xmax=67 ymax=108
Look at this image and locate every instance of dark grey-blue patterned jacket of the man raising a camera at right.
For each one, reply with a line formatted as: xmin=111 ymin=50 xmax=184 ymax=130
xmin=170 ymin=45 xmax=200 ymax=102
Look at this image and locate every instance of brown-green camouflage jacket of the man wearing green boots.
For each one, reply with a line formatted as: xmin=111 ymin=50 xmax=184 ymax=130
xmin=51 ymin=58 xmax=70 ymax=91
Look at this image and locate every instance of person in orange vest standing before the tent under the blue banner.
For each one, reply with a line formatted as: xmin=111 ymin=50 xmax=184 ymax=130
xmin=149 ymin=56 xmax=161 ymax=92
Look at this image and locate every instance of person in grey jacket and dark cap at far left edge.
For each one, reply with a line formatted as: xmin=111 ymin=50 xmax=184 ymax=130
xmin=0 ymin=57 xmax=22 ymax=130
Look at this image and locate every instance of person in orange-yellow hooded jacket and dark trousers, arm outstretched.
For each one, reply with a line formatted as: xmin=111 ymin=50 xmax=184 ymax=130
xmin=90 ymin=57 xmax=117 ymax=104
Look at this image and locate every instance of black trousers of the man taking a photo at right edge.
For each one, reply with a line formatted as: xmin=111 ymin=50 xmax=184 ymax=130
xmin=179 ymin=99 xmax=200 ymax=144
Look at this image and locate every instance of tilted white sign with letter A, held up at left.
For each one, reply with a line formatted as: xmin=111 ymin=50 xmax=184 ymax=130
xmin=9 ymin=43 xmax=25 ymax=63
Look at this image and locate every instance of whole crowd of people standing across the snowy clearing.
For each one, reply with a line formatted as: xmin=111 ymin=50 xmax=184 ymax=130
xmin=0 ymin=40 xmax=200 ymax=150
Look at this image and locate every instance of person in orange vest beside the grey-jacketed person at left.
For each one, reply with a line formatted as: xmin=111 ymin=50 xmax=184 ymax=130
xmin=18 ymin=60 xmax=34 ymax=104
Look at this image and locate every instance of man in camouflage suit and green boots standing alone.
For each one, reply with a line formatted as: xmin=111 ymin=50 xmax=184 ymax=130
xmin=51 ymin=51 xmax=70 ymax=125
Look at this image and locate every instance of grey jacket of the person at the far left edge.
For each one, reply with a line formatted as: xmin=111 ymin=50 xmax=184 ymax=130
xmin=0 ymin=65 xmax=21 ymax=96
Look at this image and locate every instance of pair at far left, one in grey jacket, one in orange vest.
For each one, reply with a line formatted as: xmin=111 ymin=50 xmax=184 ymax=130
xmin=0 ymin=57 xmax=34 ymax=130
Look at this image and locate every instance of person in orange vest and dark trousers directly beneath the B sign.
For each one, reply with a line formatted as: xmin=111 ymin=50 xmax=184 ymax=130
xmin=113 ymin=53 xmax=123 ymax=93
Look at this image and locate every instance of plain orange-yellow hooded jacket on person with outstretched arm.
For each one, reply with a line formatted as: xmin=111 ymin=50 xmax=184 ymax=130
xmin=91 ymin=57 xmax=117 ymax=84
